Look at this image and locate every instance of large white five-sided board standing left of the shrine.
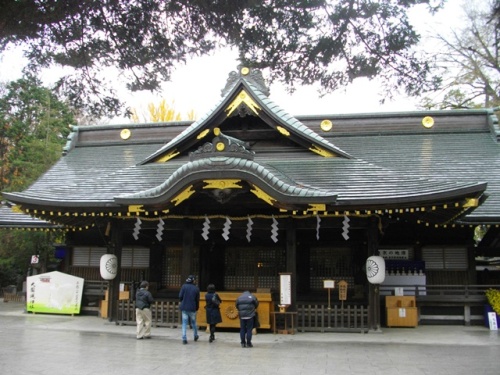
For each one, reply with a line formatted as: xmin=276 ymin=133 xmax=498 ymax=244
xmin=26 ymin=271 xmax=84 ymax=314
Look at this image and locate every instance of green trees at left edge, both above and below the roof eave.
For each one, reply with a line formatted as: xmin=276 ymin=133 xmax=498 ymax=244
xmin=0 ymin=75 xmax=74 ymax=287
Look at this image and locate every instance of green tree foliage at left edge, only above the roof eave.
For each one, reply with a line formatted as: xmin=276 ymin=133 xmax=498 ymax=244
xmin=0 ymin=76 xmax=74 ymax=191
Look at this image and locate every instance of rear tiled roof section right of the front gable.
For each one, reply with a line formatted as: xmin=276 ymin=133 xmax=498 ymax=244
xmin=301 ymin=110 xmax=500 ymax=223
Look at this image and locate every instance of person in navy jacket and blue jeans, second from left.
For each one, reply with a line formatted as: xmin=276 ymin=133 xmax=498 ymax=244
xmin=179 ymin=275 xmax=200 ymax=344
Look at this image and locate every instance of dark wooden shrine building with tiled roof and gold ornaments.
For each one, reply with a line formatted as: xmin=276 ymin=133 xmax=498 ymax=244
xmin=4 ymin=67 xmax=500 ymax=329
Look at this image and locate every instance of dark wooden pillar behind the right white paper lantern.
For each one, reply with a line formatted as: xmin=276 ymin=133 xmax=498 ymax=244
xmin=367 ymin=218 xmax=381 ymax=332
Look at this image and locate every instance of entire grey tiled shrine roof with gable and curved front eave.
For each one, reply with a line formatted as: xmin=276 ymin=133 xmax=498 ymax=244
xmin=1 ymin=67 xmax=500 ymax=229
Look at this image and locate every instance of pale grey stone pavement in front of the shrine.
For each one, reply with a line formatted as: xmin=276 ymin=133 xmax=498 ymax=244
xmin=0 ymin=302 xmax=500 ymax=375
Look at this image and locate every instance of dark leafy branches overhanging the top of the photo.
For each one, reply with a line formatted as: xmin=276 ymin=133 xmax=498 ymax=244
xmin=0 ymin=0 xmax=444 ymax=116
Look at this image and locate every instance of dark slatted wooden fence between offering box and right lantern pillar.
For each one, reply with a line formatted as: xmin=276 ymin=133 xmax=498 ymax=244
xmin=297 ymin=304 xmax=368 ymax=333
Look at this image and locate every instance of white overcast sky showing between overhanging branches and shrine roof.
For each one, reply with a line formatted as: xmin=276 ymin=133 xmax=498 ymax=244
xmin=0 ymin=0 xmax=463 ymax=123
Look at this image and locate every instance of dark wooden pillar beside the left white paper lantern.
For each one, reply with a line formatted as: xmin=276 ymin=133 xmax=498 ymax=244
xmin=108 ymin=220 xmax=123 ymax=324
